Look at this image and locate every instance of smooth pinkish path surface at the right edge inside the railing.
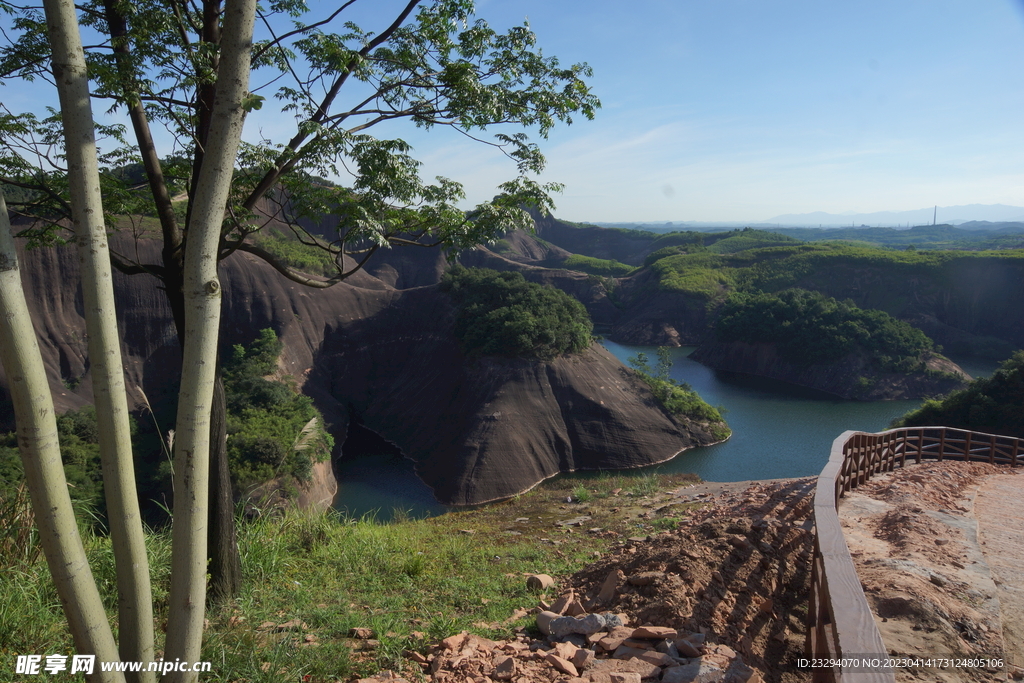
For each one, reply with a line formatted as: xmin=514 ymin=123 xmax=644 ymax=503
xmin=974 ymin=473 xmax=1024 ymax=667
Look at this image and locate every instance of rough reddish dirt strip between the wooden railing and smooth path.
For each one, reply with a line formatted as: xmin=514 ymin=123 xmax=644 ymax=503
xmin=840 ymin=462 xmax=1022 ymax=682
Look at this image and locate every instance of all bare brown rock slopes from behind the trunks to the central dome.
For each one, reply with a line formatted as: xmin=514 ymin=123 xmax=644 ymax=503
xmin=0 ymin=235 xmax=714 ymax=505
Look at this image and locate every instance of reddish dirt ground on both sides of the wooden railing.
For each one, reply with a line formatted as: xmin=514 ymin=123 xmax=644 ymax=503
xmin=368 ymin=462 xmax=1024 ymax=683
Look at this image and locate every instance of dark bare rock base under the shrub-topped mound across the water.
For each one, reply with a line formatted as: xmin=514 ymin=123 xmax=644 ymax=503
xmin=690 ymin=342 xmax=971 ymax=400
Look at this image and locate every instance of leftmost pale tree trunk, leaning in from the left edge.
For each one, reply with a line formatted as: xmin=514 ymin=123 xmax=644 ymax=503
xmin=0 ymin=191 xmax=124 ymax=683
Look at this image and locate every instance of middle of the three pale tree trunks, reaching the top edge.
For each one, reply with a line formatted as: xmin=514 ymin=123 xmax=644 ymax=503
xmin=43 ymin=0 xmax=156 ymax=683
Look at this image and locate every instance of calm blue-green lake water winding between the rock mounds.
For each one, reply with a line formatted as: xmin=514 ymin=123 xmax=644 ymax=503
xmin=335 ymin=340 xmax=997 ymax=519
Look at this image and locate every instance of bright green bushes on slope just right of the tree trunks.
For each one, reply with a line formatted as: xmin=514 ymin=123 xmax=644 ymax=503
xmin=223 ymin=329 xmax=334 ymax=486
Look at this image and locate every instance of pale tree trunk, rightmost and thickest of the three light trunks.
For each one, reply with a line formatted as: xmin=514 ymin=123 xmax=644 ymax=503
xmin=164 ymin=0 xmax=256 ymax=683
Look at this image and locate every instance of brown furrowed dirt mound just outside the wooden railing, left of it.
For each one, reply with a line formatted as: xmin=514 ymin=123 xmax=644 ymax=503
xmin=569 ymin=477 xmax=814 ymax=683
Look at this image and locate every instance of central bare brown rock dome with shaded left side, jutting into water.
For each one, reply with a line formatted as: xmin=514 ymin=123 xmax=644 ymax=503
xmin=310 ymin=289 xmax=715 ymax=505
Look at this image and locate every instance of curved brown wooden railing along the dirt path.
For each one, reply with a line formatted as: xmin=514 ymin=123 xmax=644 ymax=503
xmin=806 ymin=427 xmax=1024 ymax=683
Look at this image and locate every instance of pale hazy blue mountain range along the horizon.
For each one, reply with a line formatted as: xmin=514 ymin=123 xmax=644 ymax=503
xmin=592 ymin=204 xmax=1024 ymax=232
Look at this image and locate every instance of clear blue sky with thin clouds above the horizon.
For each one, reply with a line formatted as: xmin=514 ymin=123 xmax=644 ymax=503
xmin=0 ymin=0 xmax=1024 ymax=222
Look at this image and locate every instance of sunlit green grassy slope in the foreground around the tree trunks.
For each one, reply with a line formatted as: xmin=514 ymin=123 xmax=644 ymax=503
xmin=0 ymin=473 xmax=692 ymax=683
